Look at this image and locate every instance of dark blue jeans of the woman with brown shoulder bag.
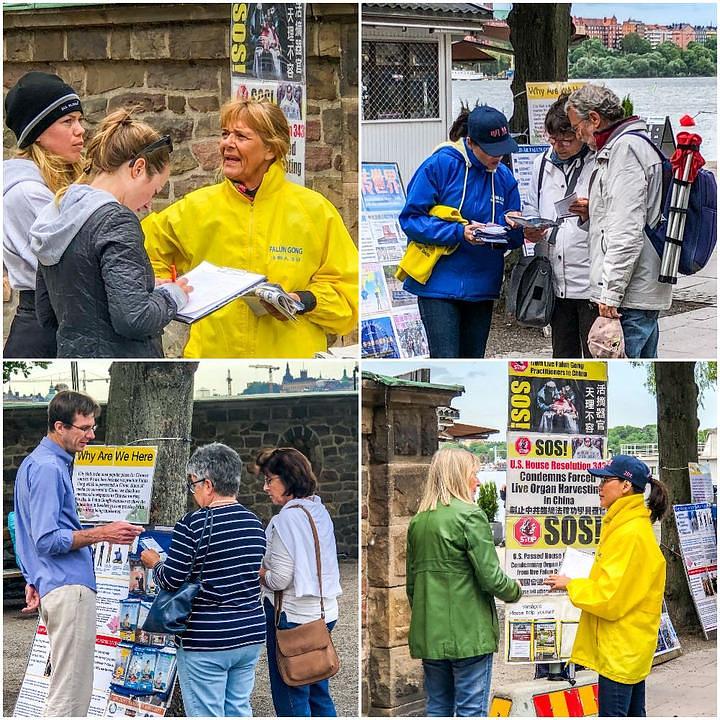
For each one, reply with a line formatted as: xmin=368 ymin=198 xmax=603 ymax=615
xmin=265 ymin=599 xmax=337 ymax=717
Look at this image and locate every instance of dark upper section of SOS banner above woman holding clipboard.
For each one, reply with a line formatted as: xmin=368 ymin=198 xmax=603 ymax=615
xmin=230 ymin=3 xmax=305 ymax=81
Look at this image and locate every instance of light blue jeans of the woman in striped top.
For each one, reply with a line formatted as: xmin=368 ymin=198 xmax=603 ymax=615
xmin=177 ymin=643 xmax=262 ymax=717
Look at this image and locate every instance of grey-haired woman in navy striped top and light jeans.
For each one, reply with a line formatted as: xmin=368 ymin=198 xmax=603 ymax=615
xmin=141 ymin=443 xmax=266 ymax=717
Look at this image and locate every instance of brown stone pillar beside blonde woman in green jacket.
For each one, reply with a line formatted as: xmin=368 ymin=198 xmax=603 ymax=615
xmin=362 ymin=373 xmax=464 ymax=717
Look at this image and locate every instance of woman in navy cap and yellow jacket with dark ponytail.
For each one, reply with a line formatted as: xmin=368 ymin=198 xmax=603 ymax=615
xmin=545 ymin=455 xmax=668 ymax=717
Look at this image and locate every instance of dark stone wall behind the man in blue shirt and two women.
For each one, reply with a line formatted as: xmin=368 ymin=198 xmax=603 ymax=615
xmin=3 ymin=392 xmax=358 ymax=566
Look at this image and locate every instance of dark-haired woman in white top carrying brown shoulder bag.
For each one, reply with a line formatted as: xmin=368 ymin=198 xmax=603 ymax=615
xmin=255 ymin=448 xmax=342 ymax=717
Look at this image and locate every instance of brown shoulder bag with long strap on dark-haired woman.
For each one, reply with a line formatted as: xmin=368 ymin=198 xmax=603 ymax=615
xmin=275 ymin=505 xmax=340 ymax=687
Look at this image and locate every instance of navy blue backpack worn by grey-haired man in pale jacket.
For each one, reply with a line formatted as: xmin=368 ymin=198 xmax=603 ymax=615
xmin=626 ymin=131 xmax=717 ymax=276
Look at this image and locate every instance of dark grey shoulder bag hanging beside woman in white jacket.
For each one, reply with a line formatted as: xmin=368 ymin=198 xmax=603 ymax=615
xmin=507 ymin=255 xmax=555 ymax=328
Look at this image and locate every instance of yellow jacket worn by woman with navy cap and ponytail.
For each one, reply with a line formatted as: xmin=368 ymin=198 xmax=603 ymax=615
xmin=567 ymin=495 xmax=665 ymax=684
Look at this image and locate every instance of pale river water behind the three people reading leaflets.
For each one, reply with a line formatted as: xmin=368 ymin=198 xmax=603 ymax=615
xmin=452 ymin=77 xmax=718 ymax=161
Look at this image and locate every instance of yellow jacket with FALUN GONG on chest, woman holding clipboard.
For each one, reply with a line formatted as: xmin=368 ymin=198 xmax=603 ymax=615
xmin=142 ymin=163 xmax=358 ymax=358
